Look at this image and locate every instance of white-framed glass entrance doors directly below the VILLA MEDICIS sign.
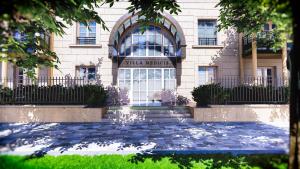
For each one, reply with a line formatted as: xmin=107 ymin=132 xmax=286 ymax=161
xmin=118 ymin=68 xmax=176 ymax=106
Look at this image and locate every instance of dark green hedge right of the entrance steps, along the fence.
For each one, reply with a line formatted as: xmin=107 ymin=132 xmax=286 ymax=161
xmin=192 ymin=84 xmax=289 ymax=107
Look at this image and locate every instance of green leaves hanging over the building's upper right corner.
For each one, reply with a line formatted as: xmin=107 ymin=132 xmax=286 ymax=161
xmin=217 ymin=0 xmax=292 ymax=48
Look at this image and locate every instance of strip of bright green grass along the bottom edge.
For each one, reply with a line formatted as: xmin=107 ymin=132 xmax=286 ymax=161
xmin=0 ymin=154 xmax=288 ymax=169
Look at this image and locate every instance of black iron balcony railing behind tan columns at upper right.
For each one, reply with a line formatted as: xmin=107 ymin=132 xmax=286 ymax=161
xmin=242 ymin=31 xmax=281 ymax=57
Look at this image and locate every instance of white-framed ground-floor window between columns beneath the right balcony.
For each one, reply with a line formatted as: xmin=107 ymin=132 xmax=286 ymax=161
xmin=256 ymin=67 xmax=273 ymax=86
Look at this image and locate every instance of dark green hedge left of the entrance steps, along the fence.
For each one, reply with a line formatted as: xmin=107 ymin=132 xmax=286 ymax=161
xmin=0 ymin=85 xmax=107 ymax=107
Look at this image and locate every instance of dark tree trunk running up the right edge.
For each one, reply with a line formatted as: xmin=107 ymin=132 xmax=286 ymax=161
xmin=289 ymin=0 xmax=300 ymax=169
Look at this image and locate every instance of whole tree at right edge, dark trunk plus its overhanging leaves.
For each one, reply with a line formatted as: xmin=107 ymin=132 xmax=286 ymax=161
xmin=217 ymin=0 xmax=300 ymax=169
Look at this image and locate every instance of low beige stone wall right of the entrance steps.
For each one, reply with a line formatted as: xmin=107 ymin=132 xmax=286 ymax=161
xmin=191 ymin=104 xmax=289 ymax=124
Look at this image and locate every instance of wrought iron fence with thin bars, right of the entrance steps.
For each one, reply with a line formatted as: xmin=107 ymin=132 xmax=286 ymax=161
xmin=204 ymin=77 xmax=289 ymax=104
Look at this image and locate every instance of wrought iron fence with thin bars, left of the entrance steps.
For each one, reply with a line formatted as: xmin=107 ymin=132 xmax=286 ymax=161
xmin=0 ymin=77 xmax=100 ymax=104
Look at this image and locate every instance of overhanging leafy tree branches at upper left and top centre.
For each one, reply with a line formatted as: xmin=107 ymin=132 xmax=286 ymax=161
xmin=0 ymin=0 xmax=180 ymax=77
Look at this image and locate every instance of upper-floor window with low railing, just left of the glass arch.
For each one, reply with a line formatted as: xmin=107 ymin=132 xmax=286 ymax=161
xmin=77 ymin=21 xmax=96 ymax=44
